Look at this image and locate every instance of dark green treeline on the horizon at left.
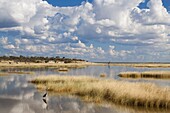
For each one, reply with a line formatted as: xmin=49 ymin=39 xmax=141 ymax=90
xmin=0 ymin=55 xmax=85 ymax=63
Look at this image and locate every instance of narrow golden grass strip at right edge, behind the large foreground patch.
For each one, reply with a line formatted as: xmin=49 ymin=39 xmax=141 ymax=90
xmin=118 ymin=71 xmax=170 ymax=79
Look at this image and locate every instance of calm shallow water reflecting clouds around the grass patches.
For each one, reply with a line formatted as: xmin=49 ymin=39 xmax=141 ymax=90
xmin=0 ymin=66 xmax=170 ymax=113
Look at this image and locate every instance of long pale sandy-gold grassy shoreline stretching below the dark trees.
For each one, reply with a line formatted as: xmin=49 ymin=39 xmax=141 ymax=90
xmin=0 ymin=62 xmax=170 ymax=68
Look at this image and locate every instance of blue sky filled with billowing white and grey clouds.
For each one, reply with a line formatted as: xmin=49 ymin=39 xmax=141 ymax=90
xmin=0 ymin=0 xmax=170 ymax=62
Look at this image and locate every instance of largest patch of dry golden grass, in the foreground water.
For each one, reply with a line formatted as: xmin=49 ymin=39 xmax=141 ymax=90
xmin=31 ymin=76 xmax=170 ymax=108
